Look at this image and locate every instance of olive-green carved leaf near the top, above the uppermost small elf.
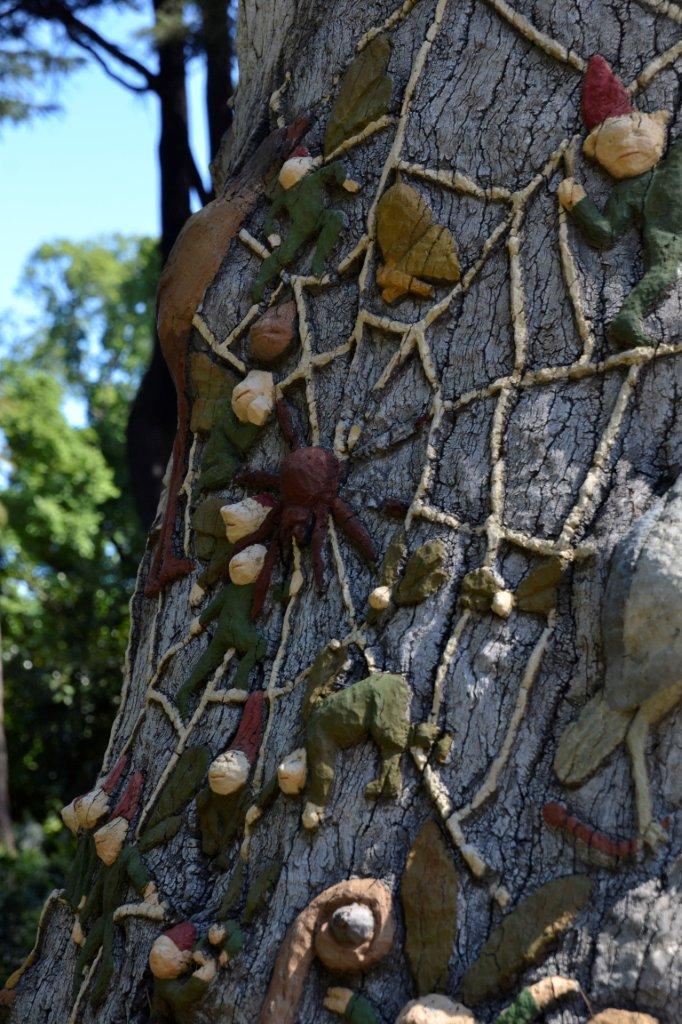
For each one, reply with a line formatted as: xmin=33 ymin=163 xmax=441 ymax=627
xmin=325 ymin=35 xmax=393 ymax=157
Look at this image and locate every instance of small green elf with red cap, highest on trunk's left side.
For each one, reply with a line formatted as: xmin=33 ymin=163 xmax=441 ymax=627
xmin=251 ymin=145 xmax=359 ymax=302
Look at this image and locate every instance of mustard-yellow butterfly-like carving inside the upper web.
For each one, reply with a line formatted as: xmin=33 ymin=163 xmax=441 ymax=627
xmin=377 ymin=182 xmax=460 ymax=303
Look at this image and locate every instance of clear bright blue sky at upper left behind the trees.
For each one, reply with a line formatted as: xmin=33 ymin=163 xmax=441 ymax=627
xmin=0 ymin=9 xmax=208 ymax=312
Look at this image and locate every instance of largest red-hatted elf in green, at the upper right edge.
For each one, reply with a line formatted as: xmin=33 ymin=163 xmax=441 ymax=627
xmin=558 ymin=55 xmax=682 ymax=348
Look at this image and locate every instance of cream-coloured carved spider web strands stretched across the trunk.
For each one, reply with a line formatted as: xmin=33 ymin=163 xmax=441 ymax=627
xmin=99 ymin=0 xmax=682 ymax=921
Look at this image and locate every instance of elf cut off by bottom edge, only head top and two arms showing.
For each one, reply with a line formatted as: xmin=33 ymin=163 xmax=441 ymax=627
xmin=325 ymin=977 xmax=580 ymax=1024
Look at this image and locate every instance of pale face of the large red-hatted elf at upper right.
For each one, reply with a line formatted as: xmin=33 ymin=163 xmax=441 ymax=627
xmin=583 ymin=111 xmax=670 ymax=178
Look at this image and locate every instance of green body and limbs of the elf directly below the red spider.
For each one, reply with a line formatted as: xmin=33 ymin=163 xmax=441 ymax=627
xmin=176 ymin=583 xmax=266 ymax=716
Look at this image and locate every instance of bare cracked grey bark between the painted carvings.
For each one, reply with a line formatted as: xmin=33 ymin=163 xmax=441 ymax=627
xmin=6 ymin=0 xmax=682 ymax=1024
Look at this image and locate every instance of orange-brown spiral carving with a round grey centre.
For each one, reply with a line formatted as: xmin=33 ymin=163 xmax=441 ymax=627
xmin=259 ymin=879 xmax=395 ymax=1024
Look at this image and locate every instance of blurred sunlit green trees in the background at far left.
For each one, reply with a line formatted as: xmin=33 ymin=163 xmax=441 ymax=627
xmin=0 ymin=237 xmax=158 ymax=820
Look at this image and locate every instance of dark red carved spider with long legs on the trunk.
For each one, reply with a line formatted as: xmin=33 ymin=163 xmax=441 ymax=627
xmin=235 ymin=401 xmax=377 ymax=618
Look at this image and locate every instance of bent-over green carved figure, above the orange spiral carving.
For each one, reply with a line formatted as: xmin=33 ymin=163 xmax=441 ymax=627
xmin=302 ymin=673 xmax=434 ymax=828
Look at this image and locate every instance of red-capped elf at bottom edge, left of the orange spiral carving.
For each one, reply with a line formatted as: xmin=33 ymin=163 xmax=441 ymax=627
xmin=150 ymin=921 xmax=244 ymax=1024
